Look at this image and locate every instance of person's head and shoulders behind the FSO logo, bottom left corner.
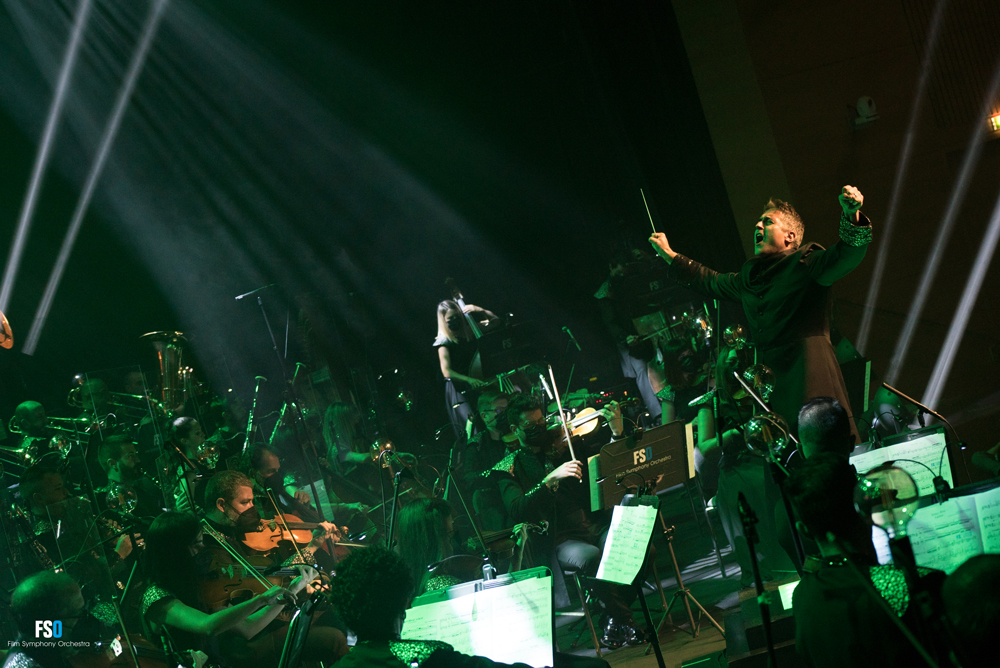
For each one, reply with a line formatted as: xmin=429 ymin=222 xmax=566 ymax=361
xmin=4 ymin=571 xmax=97 ymax=668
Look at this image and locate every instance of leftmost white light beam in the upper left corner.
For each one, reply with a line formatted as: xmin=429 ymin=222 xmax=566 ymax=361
xmin=0 ymin=0 xmax=91 ymax=312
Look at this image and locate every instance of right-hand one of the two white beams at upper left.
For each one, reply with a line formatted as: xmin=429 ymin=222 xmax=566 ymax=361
xmin=22 ymin=0 xmax=168 ymax=355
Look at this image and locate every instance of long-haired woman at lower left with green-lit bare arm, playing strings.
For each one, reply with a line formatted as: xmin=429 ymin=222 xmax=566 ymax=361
xmin=140 ymin=511 xmax=346 ymax=666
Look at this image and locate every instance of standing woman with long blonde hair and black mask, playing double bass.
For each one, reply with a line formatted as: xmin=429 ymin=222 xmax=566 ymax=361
xmin=434 ymin=299 xmax=498 ymax=439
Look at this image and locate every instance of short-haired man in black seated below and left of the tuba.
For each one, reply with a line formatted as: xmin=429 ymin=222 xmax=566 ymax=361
xmin=97 ymin=435 xmax=163 ymax=519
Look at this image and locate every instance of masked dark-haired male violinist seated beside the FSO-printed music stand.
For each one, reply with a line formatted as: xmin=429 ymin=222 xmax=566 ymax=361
xmin=491 ymin=395 xmax=641 ymax=648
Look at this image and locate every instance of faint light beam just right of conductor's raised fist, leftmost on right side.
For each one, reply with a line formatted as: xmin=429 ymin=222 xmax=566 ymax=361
xmin=855 ymin=0 xmax=948 ymax=355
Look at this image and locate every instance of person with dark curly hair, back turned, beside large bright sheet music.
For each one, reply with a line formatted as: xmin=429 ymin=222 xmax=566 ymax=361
xmin=330 ymin=547 xmax=540 ymax=668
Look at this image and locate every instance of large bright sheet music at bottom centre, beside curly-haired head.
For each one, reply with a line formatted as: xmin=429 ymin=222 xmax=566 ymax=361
xmin=402 ymin=576 xmax=553 ymax=668
